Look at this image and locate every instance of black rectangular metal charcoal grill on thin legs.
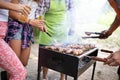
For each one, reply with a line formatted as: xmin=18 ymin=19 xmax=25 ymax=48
xmin=37 ymin=46 xmax=98 ymax=80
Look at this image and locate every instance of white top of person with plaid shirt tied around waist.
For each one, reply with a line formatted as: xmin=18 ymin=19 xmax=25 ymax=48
xmin=20 ymin=0 xmax=38 ymax=19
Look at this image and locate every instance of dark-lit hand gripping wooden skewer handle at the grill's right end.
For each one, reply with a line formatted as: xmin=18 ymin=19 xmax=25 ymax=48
xmin=104 ymin=51 xmax=120 ymax=66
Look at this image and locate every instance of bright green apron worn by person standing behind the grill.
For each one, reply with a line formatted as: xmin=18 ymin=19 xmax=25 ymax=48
xmin=39 ymin=0 xmax=69 ymax=45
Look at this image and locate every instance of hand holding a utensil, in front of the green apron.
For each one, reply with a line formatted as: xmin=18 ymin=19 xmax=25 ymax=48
xmin=29 ymin=19 xmax=47 ymax=32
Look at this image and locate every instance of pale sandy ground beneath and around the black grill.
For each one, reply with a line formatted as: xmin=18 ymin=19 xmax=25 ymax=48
xmin=1 ymin=44 xmax=118 ymax=80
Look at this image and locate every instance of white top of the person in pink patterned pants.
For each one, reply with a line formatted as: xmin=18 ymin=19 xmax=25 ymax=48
xmin=0 ymin=0 xmax=11 ymax=22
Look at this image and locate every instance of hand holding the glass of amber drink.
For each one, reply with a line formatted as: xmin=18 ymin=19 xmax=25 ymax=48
xmin=14 ymin=4 xmax=31 ymax=16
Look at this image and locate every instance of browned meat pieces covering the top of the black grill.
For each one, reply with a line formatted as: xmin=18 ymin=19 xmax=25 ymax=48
xmin=45 ymin=44 xmax=95 ymax=56
